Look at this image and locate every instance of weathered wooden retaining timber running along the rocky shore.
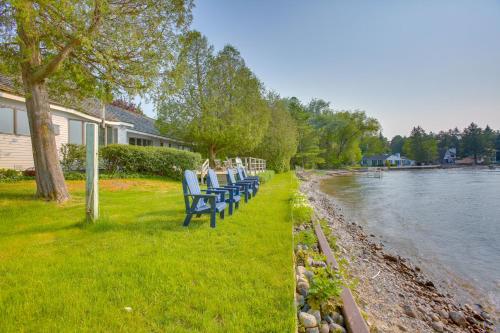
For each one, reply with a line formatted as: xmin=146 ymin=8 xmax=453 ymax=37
xmin=313 ymin=221 xmax=370 ymax=333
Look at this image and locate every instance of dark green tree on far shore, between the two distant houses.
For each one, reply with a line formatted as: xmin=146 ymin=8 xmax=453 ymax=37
xmin=403 ymin=126 xmax=438 ymax=164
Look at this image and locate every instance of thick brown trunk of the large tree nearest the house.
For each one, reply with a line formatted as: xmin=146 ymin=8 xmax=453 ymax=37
xmin=23 ymin=73 xmax=69 ymax=202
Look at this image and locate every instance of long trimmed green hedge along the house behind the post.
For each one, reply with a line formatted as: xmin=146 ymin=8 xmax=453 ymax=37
xmin=101 ymin=144 xmax=201 ymax=179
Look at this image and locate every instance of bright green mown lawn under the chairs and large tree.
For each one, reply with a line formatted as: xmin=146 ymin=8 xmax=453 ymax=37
xmin=0 ymin=173 xmax=297 ymax=332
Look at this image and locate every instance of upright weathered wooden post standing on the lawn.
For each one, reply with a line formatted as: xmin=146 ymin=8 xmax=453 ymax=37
xmin=85 ymin=123 xmax=99 ymax=223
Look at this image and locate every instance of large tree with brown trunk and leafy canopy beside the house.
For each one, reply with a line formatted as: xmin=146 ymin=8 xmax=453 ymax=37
xmin=0 ymin=0 xmax=192 ymax=202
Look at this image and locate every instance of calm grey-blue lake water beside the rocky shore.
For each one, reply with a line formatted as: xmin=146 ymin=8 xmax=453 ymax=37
xmin=321 ymin=168 xmax=500 ymax=311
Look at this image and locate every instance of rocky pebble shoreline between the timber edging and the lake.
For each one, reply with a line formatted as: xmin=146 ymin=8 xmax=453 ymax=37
xmin=298 ymin=172 xmax=495 ymax=333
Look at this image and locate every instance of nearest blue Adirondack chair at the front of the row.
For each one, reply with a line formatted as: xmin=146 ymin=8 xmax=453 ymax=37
xmin=182 ymin=170 xmax=226 ymax=228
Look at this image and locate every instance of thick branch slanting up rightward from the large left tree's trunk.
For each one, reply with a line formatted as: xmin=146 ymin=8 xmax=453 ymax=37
xmin=32 ymin=0 xmax=102 ymax=82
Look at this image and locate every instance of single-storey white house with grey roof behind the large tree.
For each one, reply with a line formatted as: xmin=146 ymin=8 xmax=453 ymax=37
xmin=0 ymin=74 xmax=191 ymax=170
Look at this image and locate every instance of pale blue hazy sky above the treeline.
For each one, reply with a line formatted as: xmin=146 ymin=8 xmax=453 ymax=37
xmin=142 ymin=0 xmax=500 ymax=137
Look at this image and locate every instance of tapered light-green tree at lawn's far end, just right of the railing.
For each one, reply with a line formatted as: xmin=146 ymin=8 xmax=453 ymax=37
xmin=254 ymin=93 xmax=298 ymax=172
